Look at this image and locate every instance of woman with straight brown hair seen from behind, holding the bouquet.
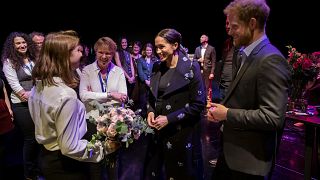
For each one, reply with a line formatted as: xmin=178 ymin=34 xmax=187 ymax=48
xmin=28 ymin=31 xmax=103 ymax=180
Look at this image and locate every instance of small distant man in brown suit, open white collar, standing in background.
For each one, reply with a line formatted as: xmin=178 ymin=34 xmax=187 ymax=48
xmin=193 ymin=34 xmax=216 ymax=93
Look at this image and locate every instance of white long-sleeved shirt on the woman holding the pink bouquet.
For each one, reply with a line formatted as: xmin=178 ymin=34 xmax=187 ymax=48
xmin=28 ymin=77 xmax=103 ymax=162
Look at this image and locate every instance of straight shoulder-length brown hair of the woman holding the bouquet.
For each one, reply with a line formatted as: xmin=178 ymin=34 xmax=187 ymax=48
xmin=32 ymin=30 xmax=79 ymax=88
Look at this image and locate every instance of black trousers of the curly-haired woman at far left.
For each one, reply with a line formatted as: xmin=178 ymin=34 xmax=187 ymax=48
xmin=12 ymin=102 xmax=40 ymax=178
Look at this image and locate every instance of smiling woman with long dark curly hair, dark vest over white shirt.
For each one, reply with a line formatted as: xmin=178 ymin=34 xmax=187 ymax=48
xmin=1 ymin=32 xmax=39 ymax=179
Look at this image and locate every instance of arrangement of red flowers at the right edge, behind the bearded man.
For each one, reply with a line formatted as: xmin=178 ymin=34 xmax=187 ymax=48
xmin=286 ymin=45 xmax=320 ymax=100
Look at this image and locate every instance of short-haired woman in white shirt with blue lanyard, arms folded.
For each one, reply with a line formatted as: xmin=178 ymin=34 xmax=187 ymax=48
xmin=79 ymin=37 xmax=127 ymax=179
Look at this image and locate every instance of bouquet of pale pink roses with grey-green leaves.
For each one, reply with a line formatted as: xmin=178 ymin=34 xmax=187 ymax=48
xmin=87 ymin=101 xmax=154 ymax=154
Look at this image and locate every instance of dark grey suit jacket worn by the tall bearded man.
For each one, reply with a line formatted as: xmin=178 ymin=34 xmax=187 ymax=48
xmin=222 ymin=39 xmax=291 ymax=176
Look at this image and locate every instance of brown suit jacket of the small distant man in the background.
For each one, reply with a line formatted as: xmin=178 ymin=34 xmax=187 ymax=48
xmin=193 ymin=44 xmax=216 ymax=74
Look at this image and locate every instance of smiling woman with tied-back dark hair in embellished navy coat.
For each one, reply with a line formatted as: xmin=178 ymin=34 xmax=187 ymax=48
xmin=146 ymin=29 xmax=206 ymax=179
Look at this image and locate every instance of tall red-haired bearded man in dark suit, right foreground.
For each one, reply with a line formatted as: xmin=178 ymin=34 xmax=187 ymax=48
xmin=207 ymin=0 xmax=290 ymax=179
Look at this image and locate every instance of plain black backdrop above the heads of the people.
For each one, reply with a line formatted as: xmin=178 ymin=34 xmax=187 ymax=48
xmin=0 ymin=0 xmax=320 ymax=59
